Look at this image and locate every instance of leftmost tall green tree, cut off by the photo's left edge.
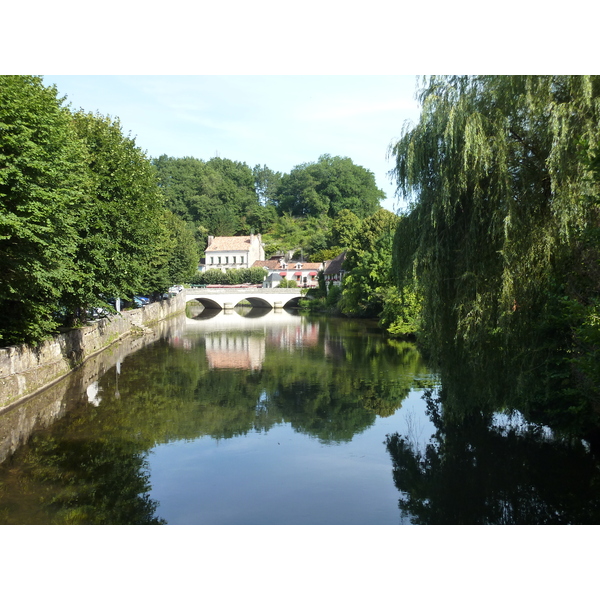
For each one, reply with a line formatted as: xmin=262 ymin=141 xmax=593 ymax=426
xmin=0 ymin=76 xmax=89 ymax=345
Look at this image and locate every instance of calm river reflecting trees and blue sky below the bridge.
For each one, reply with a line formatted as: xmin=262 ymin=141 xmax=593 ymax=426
xmin=0 ymin=309 xmax=600 ymax=525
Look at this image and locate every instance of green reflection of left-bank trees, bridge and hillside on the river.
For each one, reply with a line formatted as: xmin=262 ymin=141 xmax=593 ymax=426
xmin=0 ymin=310 xmax=434 ymax=523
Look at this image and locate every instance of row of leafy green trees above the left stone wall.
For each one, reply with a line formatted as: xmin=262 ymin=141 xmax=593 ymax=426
xmin=0 ymin=76 xmax=198 ymax=345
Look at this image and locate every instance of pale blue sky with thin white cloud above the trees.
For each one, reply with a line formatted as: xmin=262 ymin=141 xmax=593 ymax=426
xmin=44 ymin=75 xmax=419 ymax=210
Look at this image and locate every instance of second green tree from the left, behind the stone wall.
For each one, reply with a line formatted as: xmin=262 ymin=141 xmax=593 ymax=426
xmin=69 ymin=111 xmax=171 ymax=314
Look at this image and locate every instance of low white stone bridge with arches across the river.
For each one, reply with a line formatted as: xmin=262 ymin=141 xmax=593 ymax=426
xmin=183 ymin=287 xmax=302 ymax=309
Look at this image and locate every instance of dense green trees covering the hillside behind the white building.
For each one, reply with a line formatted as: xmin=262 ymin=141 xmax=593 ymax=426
xmin=152 ymin=155 xmax=385 ymax=261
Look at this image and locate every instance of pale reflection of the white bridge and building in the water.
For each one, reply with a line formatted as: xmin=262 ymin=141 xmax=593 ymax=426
xmin=185 ymin=307 xmax=319 ymax=370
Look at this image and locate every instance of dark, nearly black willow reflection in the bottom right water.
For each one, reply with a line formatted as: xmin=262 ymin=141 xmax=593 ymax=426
xmin=386 ymin=391 xmax=600 ymax=524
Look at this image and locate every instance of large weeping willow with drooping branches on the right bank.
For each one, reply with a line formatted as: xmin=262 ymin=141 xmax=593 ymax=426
xmin=390 ymin=76 xmax=600 ymax=422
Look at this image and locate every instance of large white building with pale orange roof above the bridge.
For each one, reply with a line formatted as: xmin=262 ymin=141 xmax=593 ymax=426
xmin=201 ymin=233 xmax=265 ymax=272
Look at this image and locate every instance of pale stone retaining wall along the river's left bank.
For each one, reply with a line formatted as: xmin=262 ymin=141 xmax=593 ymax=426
xmin=0 ymin=293 xmax=186 ymax=411
